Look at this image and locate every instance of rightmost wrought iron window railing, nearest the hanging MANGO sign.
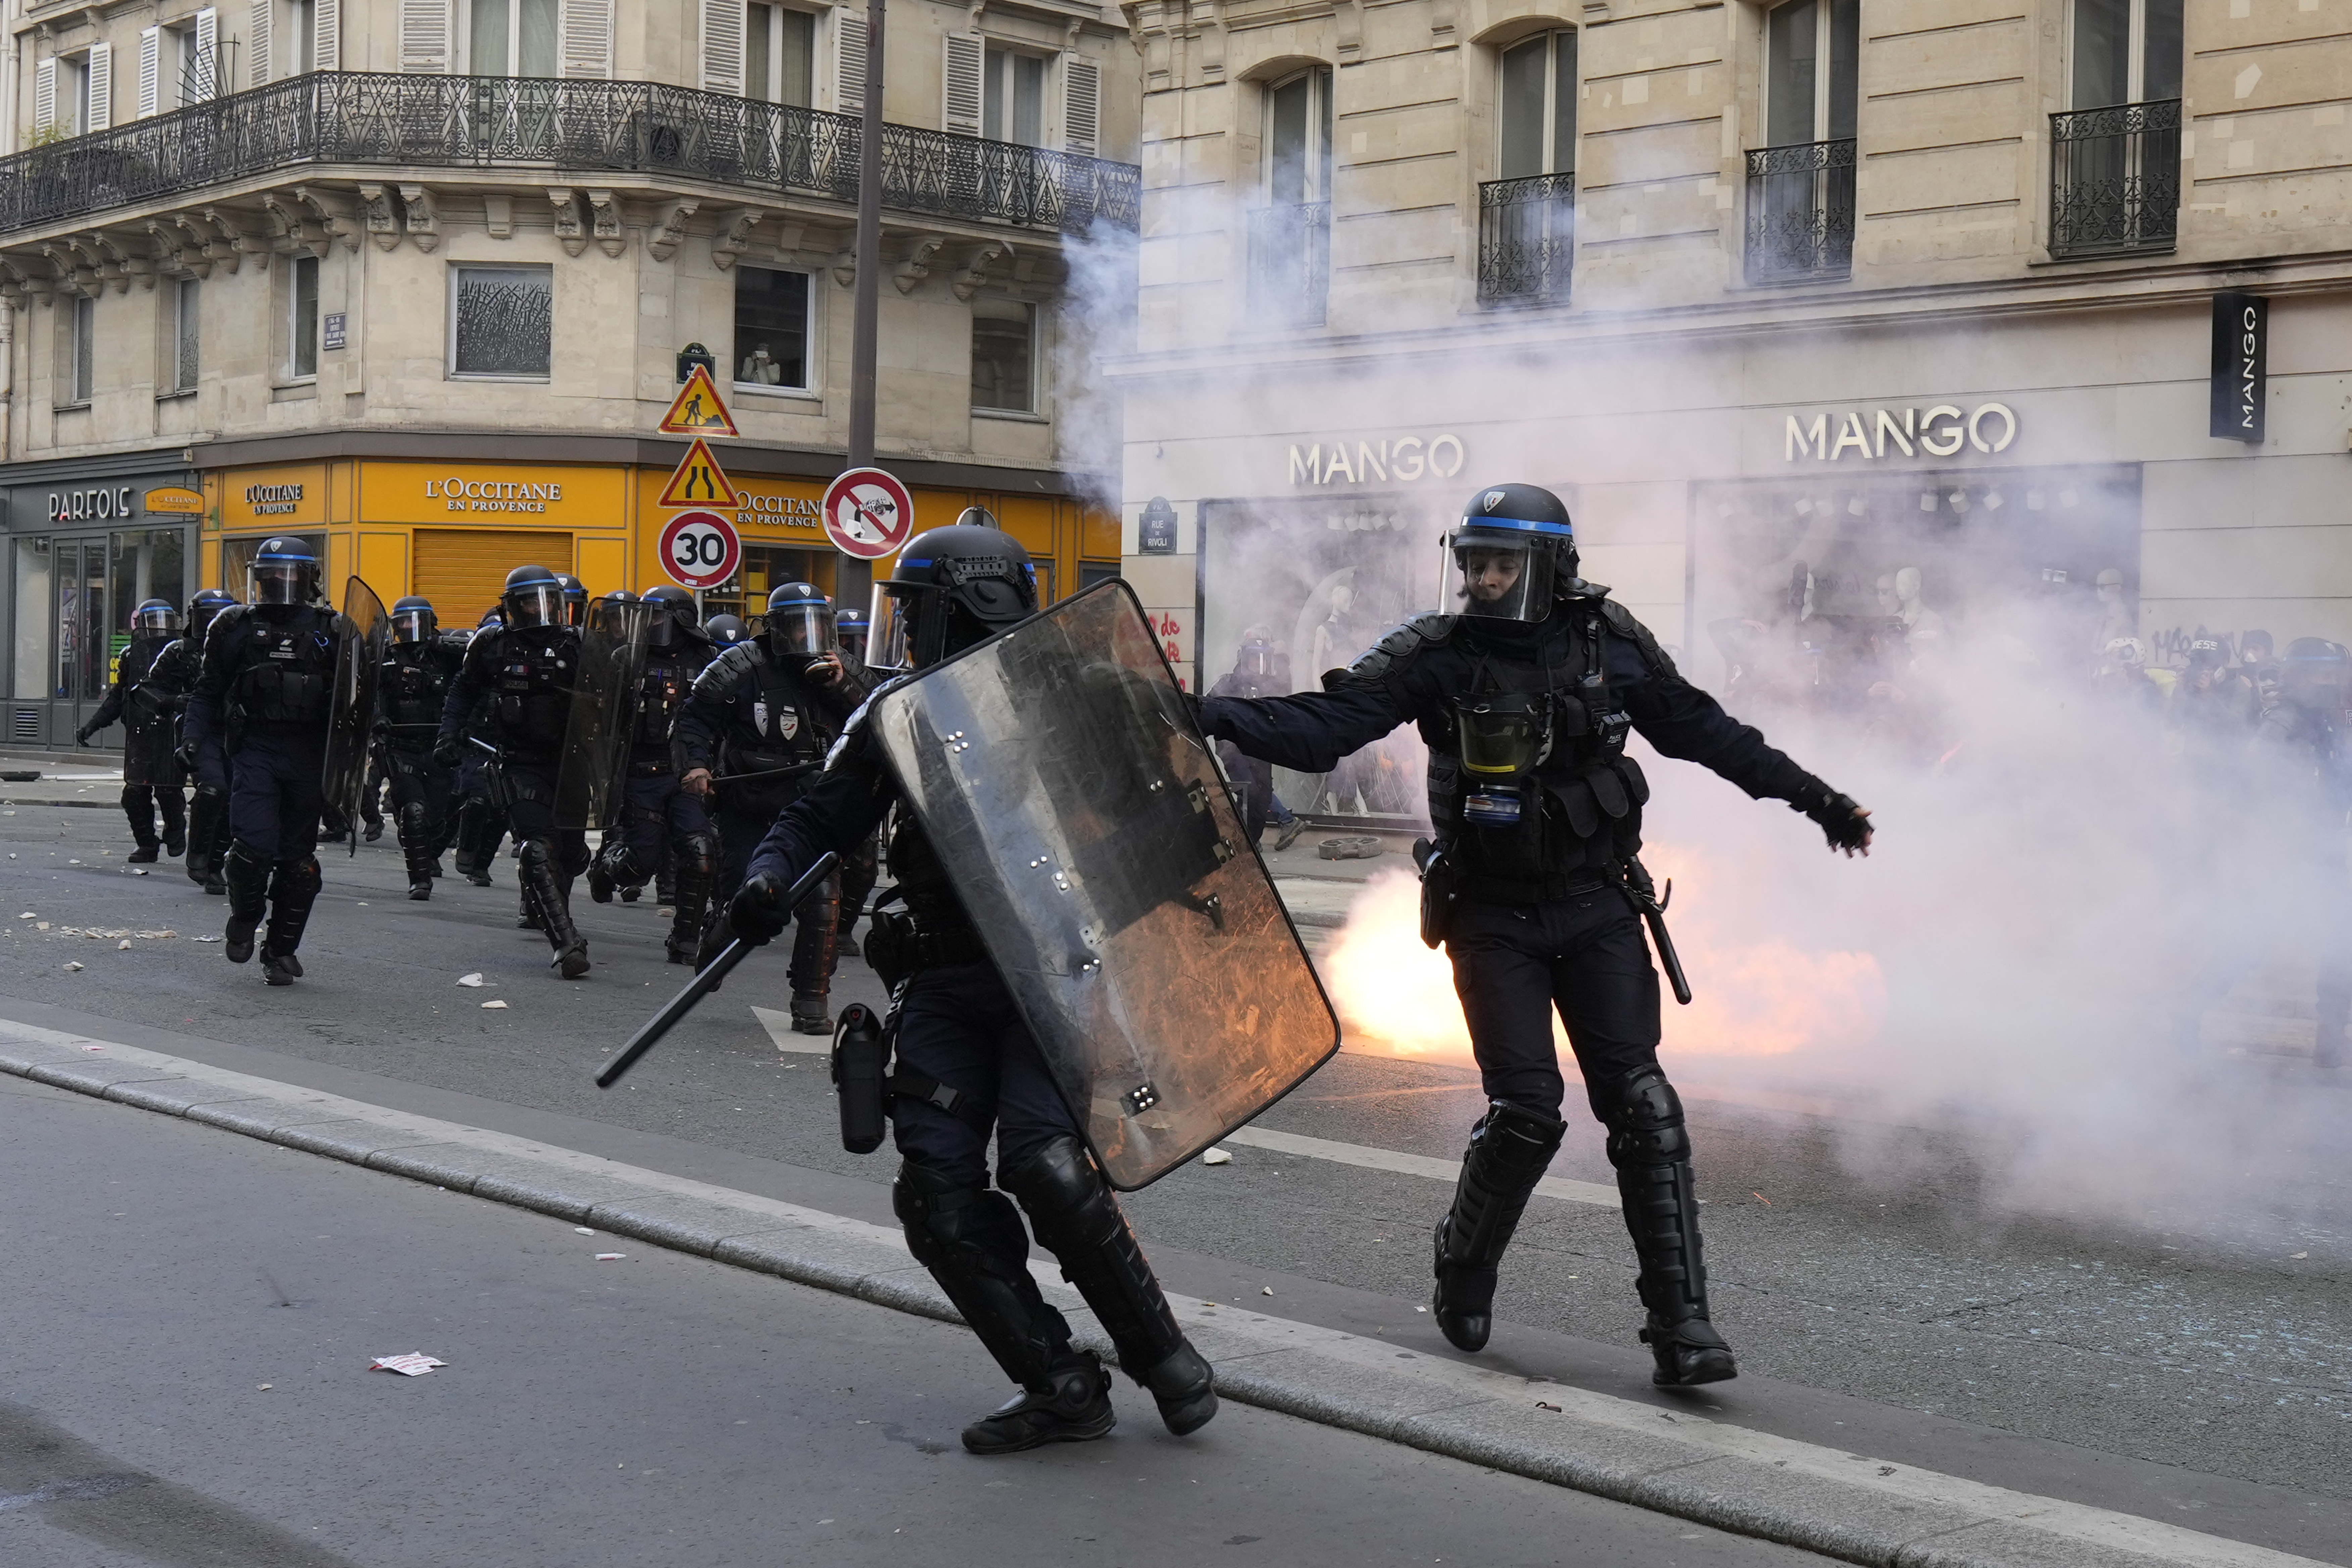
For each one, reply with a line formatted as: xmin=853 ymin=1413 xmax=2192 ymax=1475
xmin=2051 ymin=99 xmax=2180 ymax=256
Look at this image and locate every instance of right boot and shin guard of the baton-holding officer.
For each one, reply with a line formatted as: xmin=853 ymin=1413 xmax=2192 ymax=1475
xmin=997 ymin=1135 xmax=1216 ymax=1436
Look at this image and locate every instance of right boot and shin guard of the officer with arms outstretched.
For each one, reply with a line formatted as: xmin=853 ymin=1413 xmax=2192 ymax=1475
xmin=1595 ymin=1067 xmax=1738 ymax=1389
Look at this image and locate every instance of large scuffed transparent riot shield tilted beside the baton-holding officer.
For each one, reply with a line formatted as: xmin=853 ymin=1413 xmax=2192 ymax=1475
xmin=870 ymin=581 xmax=1338 ymax=1192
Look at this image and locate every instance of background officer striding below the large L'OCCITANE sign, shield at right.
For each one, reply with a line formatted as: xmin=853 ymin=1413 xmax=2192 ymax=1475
xmin=433 ymin=567 xmax=588 ymax=980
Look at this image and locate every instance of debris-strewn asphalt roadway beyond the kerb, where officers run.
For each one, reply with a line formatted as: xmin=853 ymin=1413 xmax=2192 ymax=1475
xmin=0 ymin=806 xmax=2352 ymax=1552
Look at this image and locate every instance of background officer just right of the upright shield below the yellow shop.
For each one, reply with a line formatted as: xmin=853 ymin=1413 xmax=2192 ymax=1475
xmin=588 ymin=585 xmax=720 ymax=964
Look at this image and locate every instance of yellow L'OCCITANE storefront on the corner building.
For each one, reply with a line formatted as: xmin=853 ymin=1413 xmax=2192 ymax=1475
xmin=202 ymin=458 xmax=1120 ymax=625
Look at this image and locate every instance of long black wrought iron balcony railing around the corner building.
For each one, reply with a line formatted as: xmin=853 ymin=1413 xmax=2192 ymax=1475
xmin=0 ymin=70 xmax=1143 ymax=237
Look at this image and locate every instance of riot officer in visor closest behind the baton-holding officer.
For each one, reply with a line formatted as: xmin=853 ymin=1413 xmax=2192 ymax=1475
xmin=675 ymin=583 xmax=866 ymax=1034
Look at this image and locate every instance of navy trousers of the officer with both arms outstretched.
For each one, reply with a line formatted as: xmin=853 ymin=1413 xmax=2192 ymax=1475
xmin=1447 ymin=889 xmax=1658 ymax=1119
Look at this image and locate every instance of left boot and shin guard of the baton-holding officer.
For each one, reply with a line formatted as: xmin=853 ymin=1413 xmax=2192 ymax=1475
xmin=891 ymin=1161 xmax=1117 ymax=1455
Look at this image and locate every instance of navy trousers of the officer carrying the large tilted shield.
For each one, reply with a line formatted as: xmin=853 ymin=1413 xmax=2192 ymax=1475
xmin=891 ymin=962 xmax=1077 ymax=1187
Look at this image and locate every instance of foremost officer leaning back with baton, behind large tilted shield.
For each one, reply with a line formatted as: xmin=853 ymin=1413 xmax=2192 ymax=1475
xmin=729 ymin=527 xmax=1216 ymax=1455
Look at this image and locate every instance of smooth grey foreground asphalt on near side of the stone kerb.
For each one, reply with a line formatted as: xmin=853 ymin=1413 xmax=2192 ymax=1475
xmin=0 ymin=1079 xmax=1823 ymax=1568
